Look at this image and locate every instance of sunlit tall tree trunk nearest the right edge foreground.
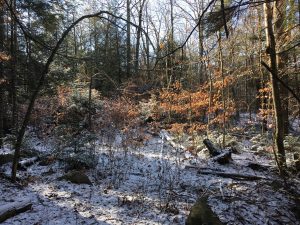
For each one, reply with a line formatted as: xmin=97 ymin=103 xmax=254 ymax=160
xmin=264 ymin=0 xmax=286 ymax=175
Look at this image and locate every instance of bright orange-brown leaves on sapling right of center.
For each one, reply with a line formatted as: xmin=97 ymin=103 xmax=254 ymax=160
xmin=159 ymin=79 xmax=235 ymax=133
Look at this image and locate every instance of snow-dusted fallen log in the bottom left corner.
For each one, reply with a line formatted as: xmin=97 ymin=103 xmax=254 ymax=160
xmin=0 ymin=199 xmax=32 ymax=223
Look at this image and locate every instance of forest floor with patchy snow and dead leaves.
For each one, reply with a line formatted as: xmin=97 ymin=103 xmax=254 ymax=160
xmin=0 ymin=115 xmax=300 ymax=225
